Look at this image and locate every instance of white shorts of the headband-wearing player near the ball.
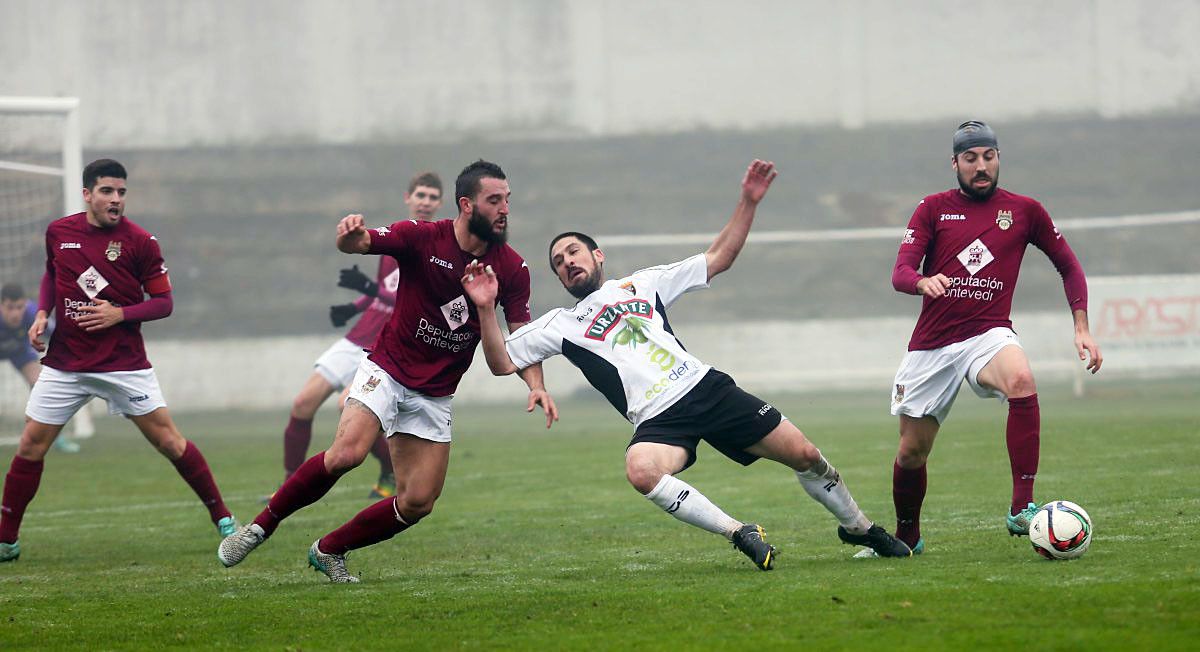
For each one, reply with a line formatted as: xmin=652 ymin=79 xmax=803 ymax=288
xmin=892 ymin=327 xmax=1021 ymax=423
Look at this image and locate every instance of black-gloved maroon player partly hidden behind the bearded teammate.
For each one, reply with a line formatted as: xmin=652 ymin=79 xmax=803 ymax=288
xmin=266 ymin=172 xmax=442 ymax=501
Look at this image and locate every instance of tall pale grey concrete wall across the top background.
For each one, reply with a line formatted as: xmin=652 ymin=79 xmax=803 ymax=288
xmin=0 ymin=0 xmax=1200 ymax=148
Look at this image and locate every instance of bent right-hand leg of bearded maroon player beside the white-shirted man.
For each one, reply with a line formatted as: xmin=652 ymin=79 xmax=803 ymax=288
xmin=308 ymin=432 xmax=450 ymax=582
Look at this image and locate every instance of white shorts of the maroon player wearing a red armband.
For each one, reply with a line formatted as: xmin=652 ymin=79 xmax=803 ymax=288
xmin=25 ymin=366 xmax=167 ymax=425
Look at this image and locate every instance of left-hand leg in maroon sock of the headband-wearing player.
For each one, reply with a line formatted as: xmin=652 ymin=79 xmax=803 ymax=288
xmin=892 ymin=414 xmax=941 ymax=550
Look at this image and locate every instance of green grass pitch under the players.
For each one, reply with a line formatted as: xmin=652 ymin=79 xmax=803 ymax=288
xmin=0 ymin=379 xmax=1200 ymax=651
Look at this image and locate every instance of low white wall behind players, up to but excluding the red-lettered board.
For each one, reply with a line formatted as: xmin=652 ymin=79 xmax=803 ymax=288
xmin=0 ymin=311 xmax=1076 ymax=414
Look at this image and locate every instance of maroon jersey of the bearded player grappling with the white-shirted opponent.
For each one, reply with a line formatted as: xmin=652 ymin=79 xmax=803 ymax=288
xmin=368 ymin=220 xmax=529 ymax=396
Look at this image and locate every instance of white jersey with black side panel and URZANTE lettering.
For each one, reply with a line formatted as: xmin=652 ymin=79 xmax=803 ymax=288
xmin=505 ymin=253 xmax=712 ymax=425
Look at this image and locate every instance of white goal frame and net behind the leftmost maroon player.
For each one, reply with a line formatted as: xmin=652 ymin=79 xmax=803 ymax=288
xmin=0 ymin=97 xmax=83 ymax=439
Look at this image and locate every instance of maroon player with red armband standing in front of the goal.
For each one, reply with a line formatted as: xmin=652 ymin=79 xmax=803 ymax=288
xmin=0 ymin=158 xmax=236 ymax=562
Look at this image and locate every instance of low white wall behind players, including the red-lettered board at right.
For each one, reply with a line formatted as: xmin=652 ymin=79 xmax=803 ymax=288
xmin=0 ymin=302 xmax=1200 ymax=417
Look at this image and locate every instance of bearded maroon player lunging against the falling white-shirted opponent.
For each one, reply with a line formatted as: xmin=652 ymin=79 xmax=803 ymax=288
xmin=217 ymin=161 xmax=558 ymax=582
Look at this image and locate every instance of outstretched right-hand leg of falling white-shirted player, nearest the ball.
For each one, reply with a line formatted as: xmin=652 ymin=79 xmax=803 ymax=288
xmin=746 ymin=419 xmax=912 ymax=557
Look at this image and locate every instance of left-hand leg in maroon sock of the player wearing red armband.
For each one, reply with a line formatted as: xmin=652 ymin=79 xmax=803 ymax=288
xmin=0 ymin=418 xmax=62 ymax=562
